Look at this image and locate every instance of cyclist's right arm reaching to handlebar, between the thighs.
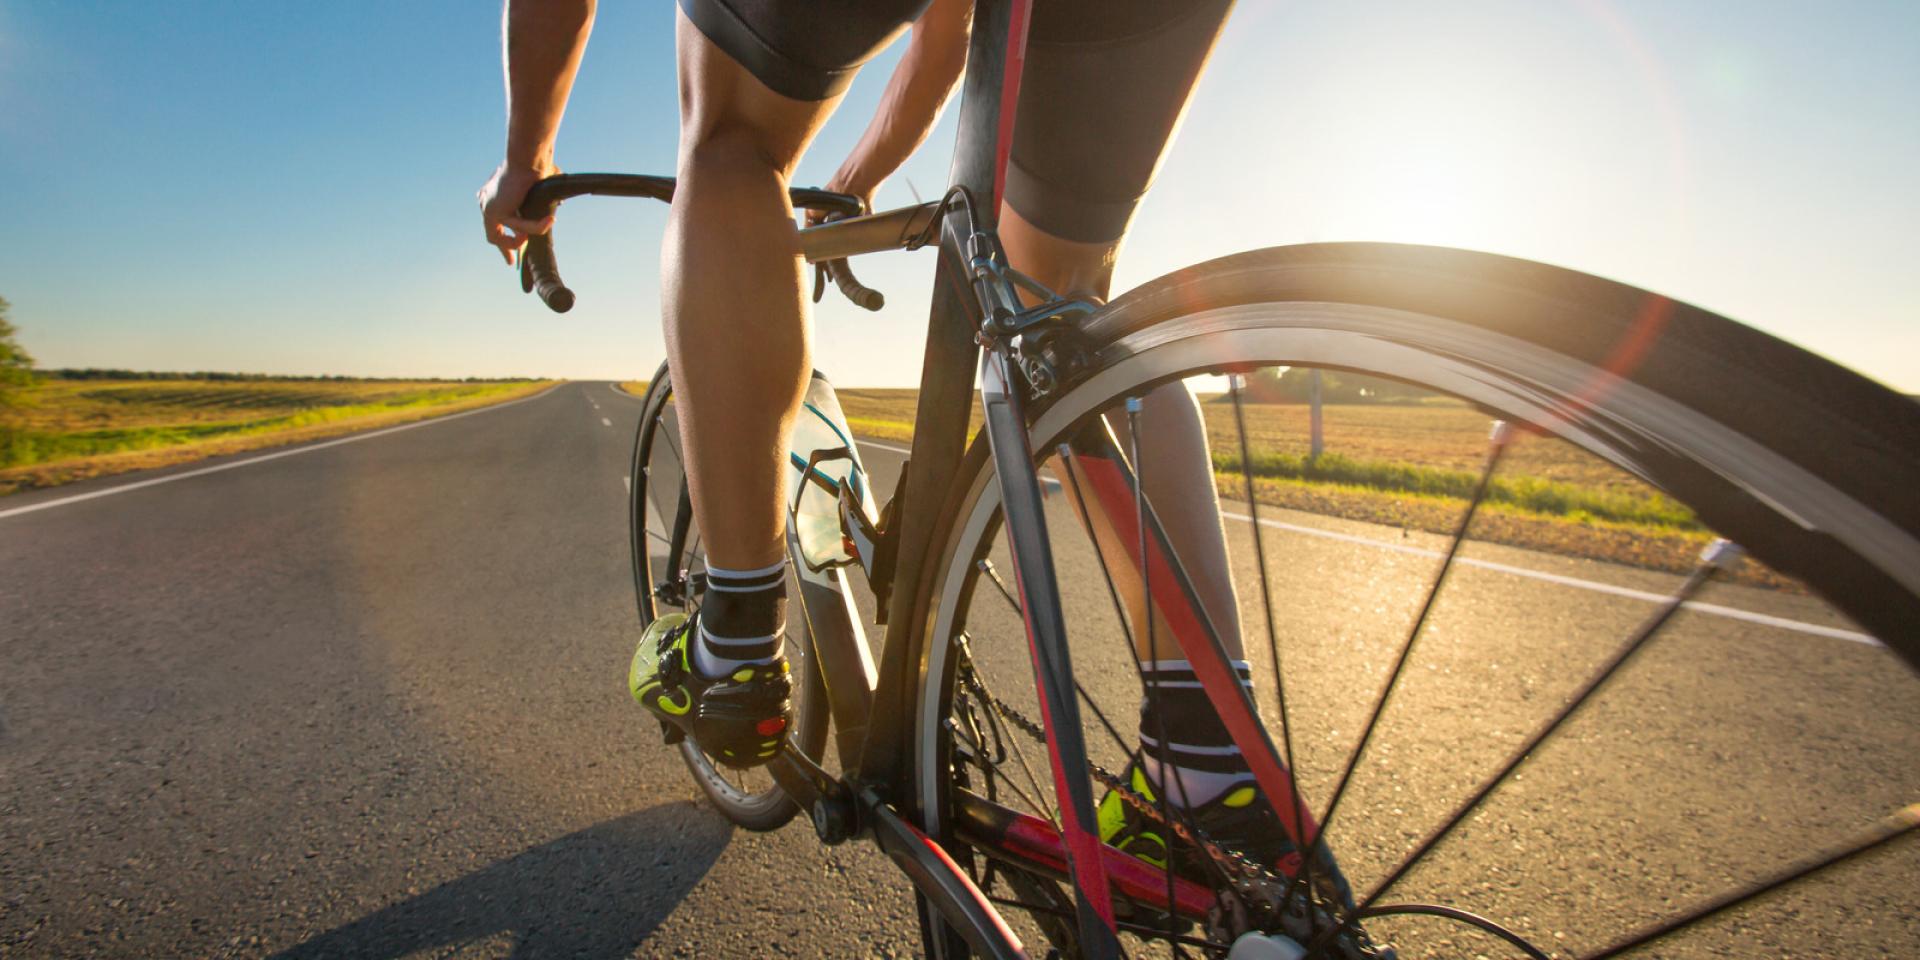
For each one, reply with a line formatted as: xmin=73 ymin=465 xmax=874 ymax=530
xmin=828 ymin=0 xmax=973 ymax=210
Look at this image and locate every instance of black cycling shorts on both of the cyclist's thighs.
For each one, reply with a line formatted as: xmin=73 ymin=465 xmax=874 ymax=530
xmin=680 ymin=0 xmax=1233 ymax=244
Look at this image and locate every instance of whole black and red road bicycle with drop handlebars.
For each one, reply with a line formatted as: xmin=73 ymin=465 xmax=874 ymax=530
xmin=506 ymin=0 xmax=1920 ymax=960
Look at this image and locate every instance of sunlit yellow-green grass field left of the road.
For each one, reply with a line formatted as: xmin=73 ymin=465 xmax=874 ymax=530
xmin=0 ymin=376 xmax=547 ymax=493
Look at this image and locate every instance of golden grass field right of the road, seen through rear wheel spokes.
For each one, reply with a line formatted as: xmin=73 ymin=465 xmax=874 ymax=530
xmin=839 ymin=390 xmax=1793 ymax=588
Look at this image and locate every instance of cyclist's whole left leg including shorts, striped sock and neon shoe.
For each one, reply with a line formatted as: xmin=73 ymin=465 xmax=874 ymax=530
xmin=628 ymin=0 xmax=912 ymax=766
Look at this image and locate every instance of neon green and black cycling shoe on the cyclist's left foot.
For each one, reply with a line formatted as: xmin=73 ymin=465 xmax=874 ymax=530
xmin=626 ymin=612 xmax=793 ymax=766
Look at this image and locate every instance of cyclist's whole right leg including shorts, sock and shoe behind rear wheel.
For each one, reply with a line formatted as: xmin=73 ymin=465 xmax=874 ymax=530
xmin=1000 ymin=0 xmax=1346 ymax=895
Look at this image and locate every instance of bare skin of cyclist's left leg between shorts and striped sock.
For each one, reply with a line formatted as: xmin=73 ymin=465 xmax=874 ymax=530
xmin=660 ymin=13 xmax=837 ymax=570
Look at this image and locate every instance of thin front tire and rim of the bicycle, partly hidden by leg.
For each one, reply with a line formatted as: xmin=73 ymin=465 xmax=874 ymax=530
xmin=628 ymin=363 xmax=828 ymax=831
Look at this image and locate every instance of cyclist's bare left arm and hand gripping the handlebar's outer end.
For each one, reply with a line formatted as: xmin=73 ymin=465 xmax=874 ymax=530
xmin=480 ymin=0 xmax=595 ymax=263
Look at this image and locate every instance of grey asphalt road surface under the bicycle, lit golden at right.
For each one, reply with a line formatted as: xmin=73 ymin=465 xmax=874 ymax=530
xmin=0 ymin=384 xmax=1920 ymax=958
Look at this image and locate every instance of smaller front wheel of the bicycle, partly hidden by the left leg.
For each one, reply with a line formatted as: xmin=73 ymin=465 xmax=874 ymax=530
xmin=628 ymin=365 xmax=828 ymax=831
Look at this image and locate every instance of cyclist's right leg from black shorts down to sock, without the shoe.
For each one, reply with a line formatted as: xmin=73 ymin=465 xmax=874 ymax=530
xmin=1000 ymin=0 xmax=1242 ymax=660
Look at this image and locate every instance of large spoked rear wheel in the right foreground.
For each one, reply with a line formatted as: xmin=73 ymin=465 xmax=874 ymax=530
xmin=914 ymin=244 xmax=1920 ymax=956
